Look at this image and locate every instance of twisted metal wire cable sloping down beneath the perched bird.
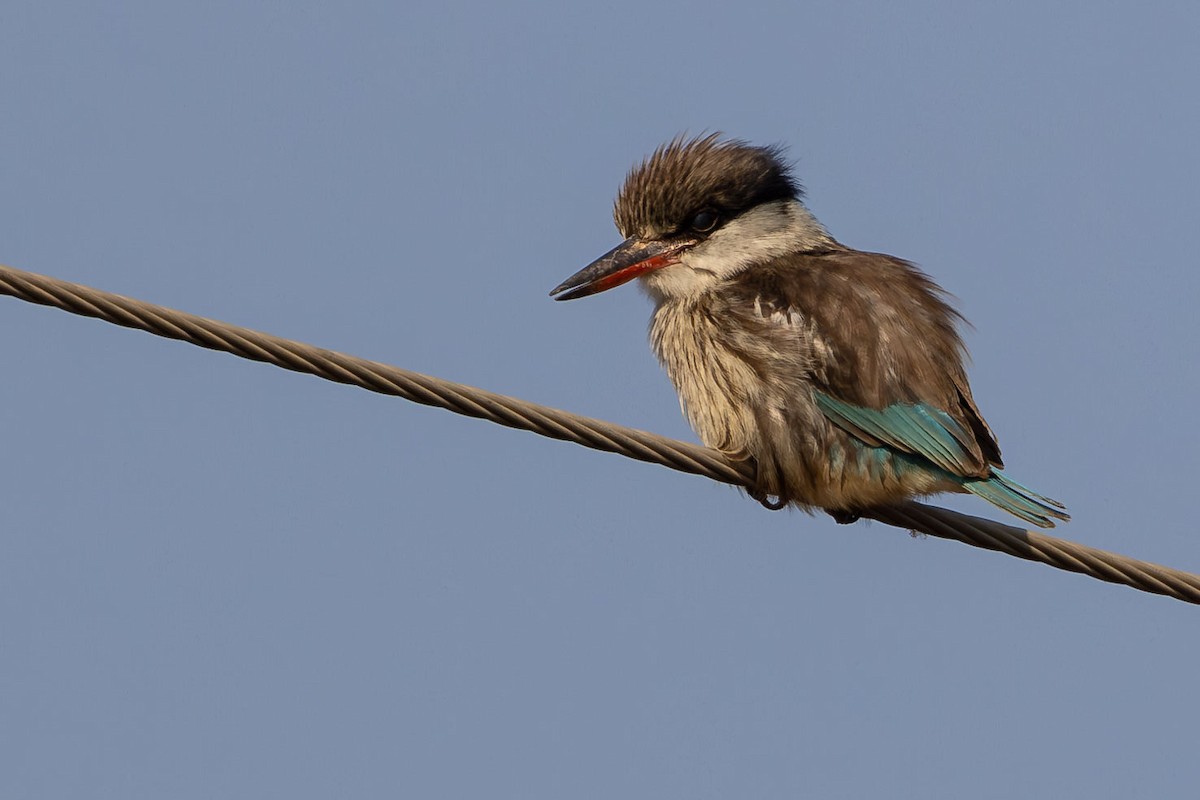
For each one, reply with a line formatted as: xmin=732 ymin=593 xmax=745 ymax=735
xmin=0 ymin=266 xmax=1200 ymax=603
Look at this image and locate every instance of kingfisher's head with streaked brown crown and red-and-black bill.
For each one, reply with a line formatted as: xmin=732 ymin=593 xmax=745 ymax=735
xmin=550 ymin=133 xmax=833 ymax=301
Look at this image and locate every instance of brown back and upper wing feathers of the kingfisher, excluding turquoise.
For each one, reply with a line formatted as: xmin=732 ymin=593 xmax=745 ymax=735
xmin=731 ymin=249 xmax=1002 ymax=476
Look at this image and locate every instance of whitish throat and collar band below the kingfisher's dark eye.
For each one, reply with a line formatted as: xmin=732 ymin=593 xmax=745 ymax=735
xmin=638 ymin=200 xmax=833 ymax=305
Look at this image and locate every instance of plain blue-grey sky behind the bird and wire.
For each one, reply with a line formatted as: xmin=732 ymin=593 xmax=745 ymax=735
xmin=0 ymin=0 xmax=1200 ymax=798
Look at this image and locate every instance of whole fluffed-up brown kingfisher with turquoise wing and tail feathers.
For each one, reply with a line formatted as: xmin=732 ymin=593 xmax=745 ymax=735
xmin=551 ymin=134 xmax=1069 ymax=528
